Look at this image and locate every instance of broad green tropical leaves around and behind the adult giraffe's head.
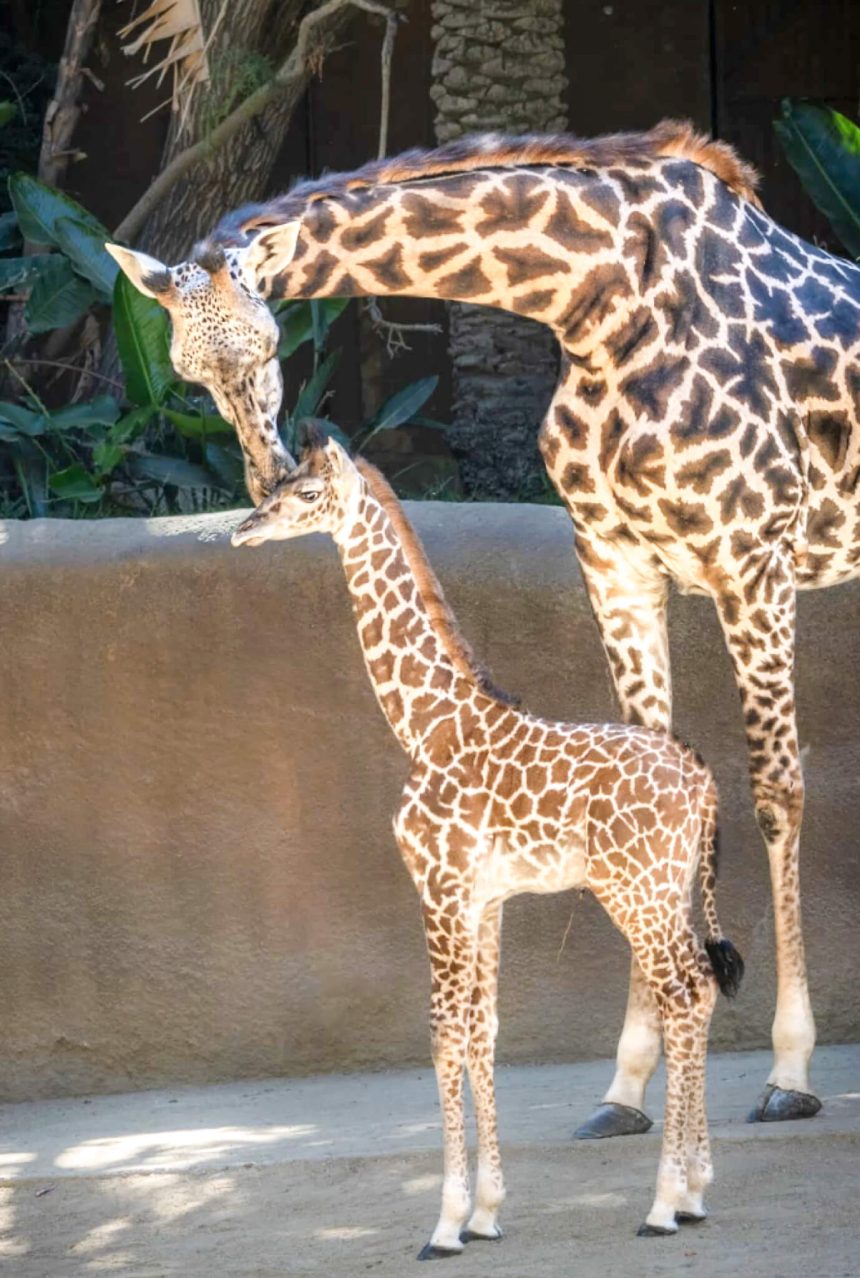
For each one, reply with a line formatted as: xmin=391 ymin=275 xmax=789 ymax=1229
xmin=0 ymin=174 xmax=437 ymax=516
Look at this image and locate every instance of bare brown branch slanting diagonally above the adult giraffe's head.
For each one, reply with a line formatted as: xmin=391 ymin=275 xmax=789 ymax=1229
xmin=114 ymin=0 xmax=396 ymax=242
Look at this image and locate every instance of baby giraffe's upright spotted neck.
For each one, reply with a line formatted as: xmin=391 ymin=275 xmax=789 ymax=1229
xmin=335 ymin=463 xmax=493 ymax=757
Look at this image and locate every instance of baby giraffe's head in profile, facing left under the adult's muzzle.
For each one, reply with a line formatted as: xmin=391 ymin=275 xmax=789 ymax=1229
xmin=227 ymin=429 xmax=362 ymax=546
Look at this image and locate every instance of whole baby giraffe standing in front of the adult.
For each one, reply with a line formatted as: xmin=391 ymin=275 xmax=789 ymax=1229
xmin=233 ymin=435 xmax=744 ymax=1260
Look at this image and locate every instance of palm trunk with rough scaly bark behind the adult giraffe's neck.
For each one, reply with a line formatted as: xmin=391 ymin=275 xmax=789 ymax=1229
xmin=431 ymin=0 xmax=566 ymax=498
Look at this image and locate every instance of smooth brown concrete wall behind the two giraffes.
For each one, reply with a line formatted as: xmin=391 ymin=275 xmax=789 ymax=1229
xmin=0 ymin=504 xmax=860 ymax=1099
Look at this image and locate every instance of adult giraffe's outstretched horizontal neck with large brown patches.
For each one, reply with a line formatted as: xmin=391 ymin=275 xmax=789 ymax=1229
xmin=269 ymin=169 xmax=635 ymax=353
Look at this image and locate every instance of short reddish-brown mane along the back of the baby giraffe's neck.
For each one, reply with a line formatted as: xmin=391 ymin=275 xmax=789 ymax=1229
xmin=353 ymin=458 xmax=519 ymax=705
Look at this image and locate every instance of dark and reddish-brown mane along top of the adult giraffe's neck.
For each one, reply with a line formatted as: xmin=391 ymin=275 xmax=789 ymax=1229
xmin=212 ymin=120 xmax=759 ymax=243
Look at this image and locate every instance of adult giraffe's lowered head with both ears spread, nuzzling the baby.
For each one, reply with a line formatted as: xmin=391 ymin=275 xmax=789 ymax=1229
xmin=105 ymin=230 xmax=305 ymax=504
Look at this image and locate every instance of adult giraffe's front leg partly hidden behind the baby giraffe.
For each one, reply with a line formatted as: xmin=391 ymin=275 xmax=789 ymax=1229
xmin=575 ymin=532 xmax=672 ymax=1140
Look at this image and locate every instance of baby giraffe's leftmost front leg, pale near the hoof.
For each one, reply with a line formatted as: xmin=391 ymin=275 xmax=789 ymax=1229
xmin=418 ymin=902 xmax=478 ymax=1260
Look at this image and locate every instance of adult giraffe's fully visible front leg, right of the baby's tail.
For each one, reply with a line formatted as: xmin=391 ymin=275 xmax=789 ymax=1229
xmin=717 ymin=548 xmax=822 ymax=1122
